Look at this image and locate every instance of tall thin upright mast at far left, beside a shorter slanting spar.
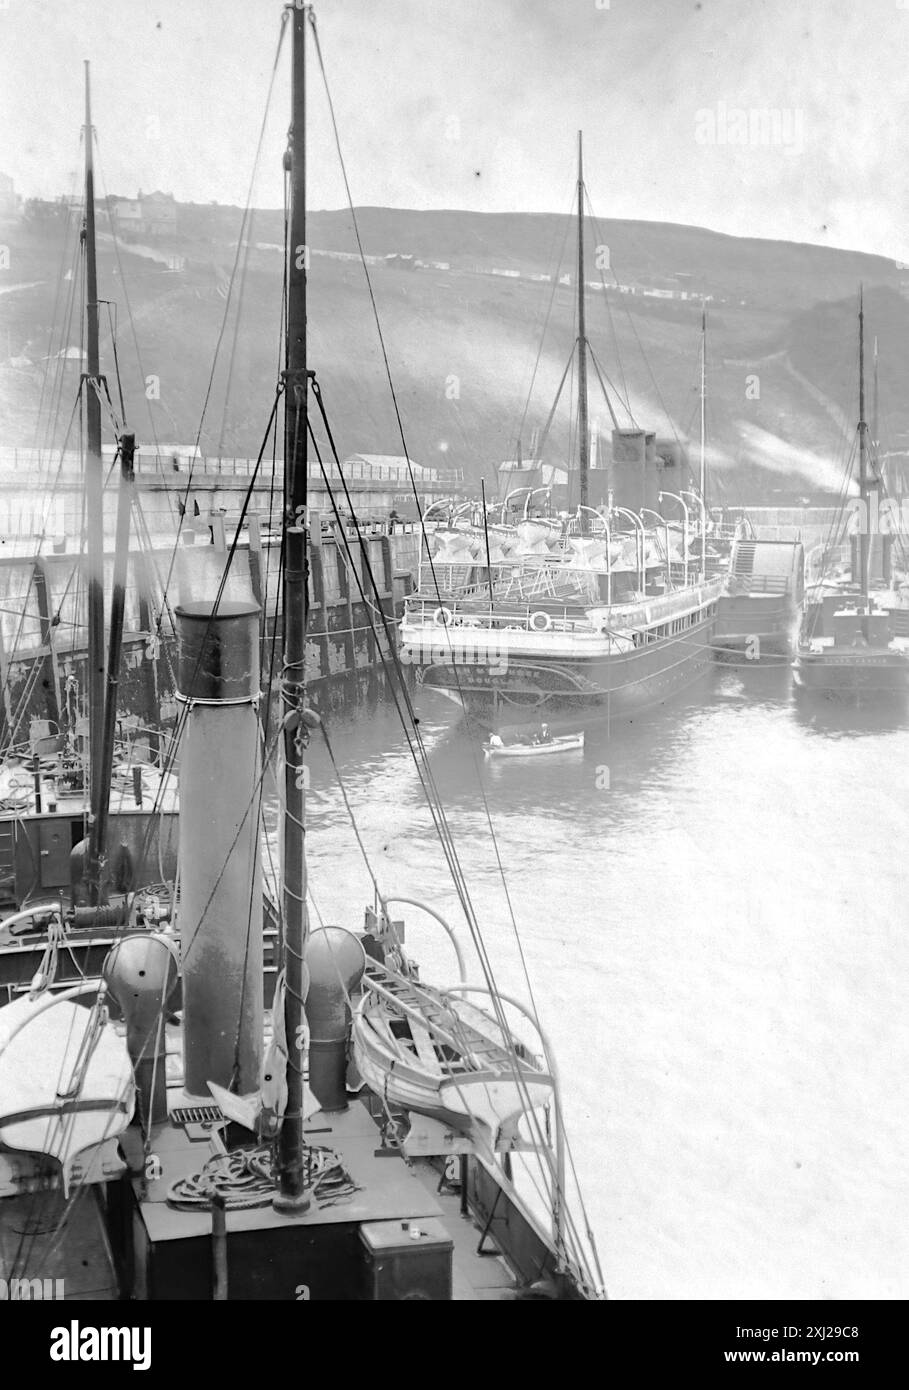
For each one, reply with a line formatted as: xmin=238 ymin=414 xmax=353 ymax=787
xmin=82 ymin=61 xmax=106 ymax=902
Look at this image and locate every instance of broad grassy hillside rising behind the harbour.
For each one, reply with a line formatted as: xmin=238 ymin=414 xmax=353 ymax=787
xmin=0 ymin=204 xmax=909 ymax=502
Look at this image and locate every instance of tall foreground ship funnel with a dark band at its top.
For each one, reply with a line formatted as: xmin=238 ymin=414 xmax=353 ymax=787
xmin=175 ymin=600 xmax=263 ymax=1097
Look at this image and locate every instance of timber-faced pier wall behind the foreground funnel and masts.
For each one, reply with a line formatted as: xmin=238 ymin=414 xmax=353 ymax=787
xmin=0 ymin=517 xmax=418 ymax=746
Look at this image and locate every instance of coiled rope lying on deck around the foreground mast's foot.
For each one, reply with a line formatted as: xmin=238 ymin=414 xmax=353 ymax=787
xmin=167 ymin=1144 xmax=359 ymax=1211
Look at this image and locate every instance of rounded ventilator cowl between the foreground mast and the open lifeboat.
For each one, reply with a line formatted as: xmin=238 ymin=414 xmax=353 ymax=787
xmin=306 ymin=927 xmax=366 ymax=1111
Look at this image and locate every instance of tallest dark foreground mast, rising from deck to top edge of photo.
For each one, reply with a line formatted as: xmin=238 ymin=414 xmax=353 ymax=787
xmin=275 ymin=0 xmax=309 ymax=1211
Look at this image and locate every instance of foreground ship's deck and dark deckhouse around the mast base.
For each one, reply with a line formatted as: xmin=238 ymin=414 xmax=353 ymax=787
xmin=0 ymin=1050 xmax=578 ymax=1301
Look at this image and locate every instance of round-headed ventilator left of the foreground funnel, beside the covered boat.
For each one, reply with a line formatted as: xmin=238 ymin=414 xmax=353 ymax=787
xmin=101 ymin=931 xmax=179 ymax=1130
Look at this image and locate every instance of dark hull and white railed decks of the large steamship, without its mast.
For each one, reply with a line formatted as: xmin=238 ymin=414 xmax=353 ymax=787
xmin=400 ymin=467 xmax=724 ymax=727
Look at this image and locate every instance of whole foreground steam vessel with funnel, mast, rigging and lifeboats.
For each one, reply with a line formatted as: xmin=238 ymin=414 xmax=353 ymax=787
xmin=0 ymin=0 xmax=602 ymax=1301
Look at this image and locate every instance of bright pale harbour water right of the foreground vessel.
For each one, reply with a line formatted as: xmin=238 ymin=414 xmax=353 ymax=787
xmin=297 ymin=662 xmax=909 ymax=1300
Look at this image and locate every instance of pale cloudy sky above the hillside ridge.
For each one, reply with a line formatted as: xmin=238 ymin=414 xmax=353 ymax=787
xmin=0 ymin=0 xmax=909 ymax=261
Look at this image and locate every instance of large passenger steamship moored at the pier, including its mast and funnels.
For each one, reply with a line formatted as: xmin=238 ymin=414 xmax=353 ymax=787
xmin=400 ymin=138 xmax=724 ymax=728
